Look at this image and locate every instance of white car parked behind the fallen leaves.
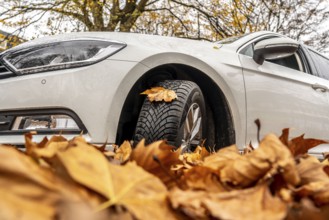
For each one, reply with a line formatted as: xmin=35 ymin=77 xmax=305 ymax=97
xmin=0 ymin=32 xmax=329 ymax=155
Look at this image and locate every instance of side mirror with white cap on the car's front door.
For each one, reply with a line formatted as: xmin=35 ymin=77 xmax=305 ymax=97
xmin=253 ymin=37 xmax=299 ymax=65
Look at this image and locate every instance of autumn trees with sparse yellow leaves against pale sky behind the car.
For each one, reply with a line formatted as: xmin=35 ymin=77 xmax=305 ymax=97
xmin=0 ymin=0 xmax=329 ymax=50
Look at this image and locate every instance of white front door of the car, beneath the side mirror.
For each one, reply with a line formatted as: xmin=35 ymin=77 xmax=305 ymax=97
xmin=239 ymin=36 xmax=329 ymax=144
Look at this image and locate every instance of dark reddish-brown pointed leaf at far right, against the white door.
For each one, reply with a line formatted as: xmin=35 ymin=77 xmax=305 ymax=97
xmin=279 ymin=128 xmax=328 ymax=156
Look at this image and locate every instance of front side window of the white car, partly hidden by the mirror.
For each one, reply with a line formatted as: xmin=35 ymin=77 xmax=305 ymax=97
xmin=240 ymin=38 xmax=305 ymax=72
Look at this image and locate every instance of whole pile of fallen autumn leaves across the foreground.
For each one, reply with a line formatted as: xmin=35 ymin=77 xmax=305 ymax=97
xmin=0 ymin=129 xmax=329 ymax=220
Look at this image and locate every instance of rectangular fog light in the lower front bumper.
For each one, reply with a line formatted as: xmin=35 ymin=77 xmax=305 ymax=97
xmin=11 ymin=115 xmax=80 ymax=131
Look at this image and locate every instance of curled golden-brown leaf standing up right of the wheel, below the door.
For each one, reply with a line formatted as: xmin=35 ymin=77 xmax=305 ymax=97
xmin=215 ymin=134 xmax=300 ymax=187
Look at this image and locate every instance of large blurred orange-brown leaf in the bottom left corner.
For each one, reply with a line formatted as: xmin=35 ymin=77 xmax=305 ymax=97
xmin=0 ymin=146 xmax=60 ymax=220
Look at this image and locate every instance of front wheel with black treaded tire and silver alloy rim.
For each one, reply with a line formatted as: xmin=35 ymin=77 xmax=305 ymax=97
xmin=134 ymin=80 xmax=207 ymax=152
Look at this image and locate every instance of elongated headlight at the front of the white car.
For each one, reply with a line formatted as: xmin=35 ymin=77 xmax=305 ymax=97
xmin=1 ymin=39 xmax=126 ymax=75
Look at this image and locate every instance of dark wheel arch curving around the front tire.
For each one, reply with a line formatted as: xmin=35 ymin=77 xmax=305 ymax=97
xmin=116 ymin=54 xmax=236 ymax=148
